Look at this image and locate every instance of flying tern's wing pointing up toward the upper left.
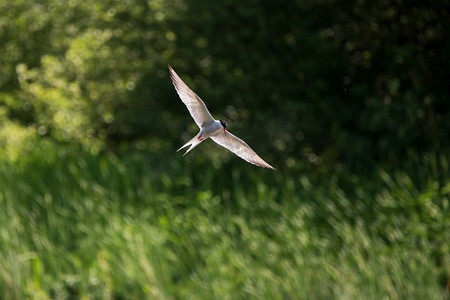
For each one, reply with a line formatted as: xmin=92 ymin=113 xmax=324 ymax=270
xmin=169 ymin=66 xmax=214 ymax=128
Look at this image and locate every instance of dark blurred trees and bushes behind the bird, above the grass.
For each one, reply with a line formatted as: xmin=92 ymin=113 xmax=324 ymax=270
xmin=0 ymin=0 xmax=450 ymax=168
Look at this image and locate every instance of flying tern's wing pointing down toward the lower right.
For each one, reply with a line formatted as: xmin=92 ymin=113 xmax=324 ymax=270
xmin=211 ymin=131 xmax=276 ymax=170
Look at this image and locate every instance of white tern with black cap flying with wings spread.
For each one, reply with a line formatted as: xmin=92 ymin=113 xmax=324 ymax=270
xmin=169 ymin=65 xmax=275 ymax=170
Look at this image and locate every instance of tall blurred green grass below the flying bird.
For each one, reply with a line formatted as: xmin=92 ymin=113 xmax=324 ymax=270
xmin=0 ymin=144 xmax=450 ymax=299
